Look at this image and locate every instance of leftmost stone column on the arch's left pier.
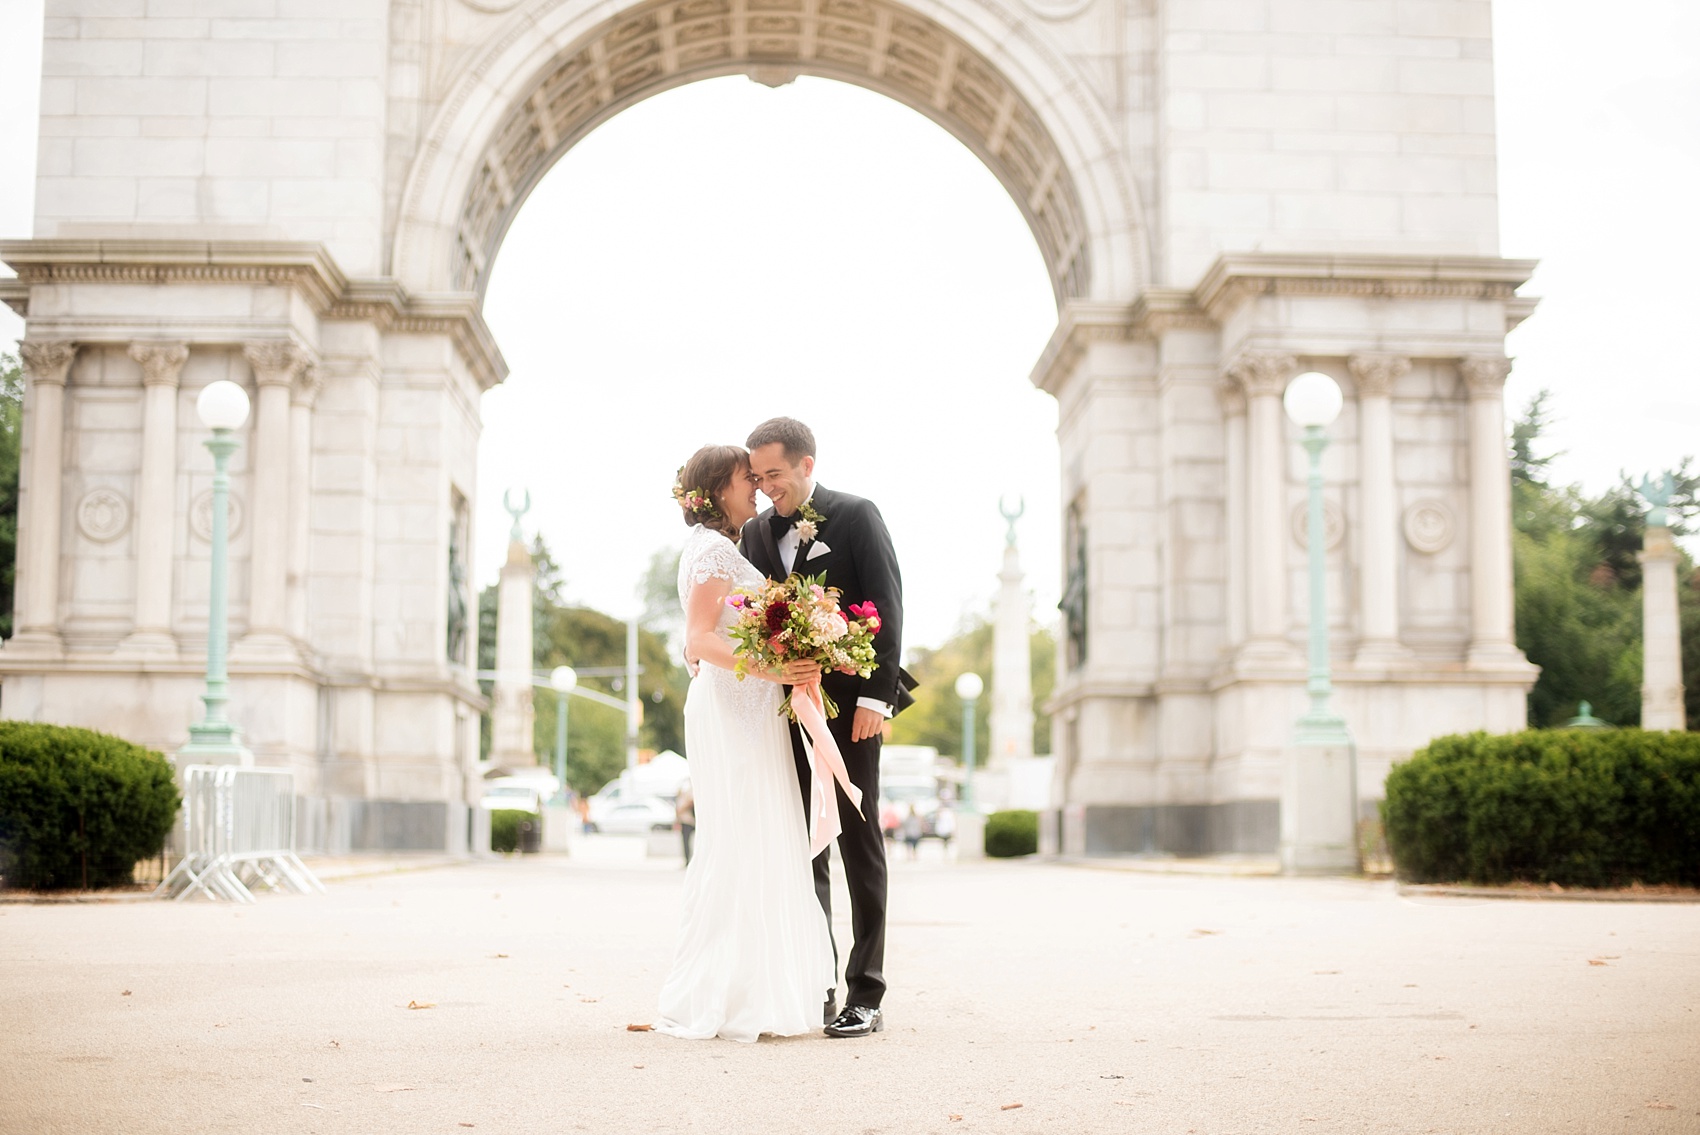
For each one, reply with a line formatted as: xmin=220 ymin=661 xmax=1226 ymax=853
xmin=7 ymin=340 xmax=77 ymax=654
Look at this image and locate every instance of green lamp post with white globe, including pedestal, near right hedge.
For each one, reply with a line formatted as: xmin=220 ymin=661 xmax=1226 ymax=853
xmin=1280 ymin=370 xmax=1358 ymax=873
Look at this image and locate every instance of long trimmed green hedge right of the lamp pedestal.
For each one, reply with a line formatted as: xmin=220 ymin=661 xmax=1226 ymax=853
xmin=1382 ymin=729 xmax=1700 ymax=887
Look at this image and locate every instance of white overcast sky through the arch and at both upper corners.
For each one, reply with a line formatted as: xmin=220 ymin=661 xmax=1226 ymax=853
xmin=0 ymin=0 xmax=1700 ymax=644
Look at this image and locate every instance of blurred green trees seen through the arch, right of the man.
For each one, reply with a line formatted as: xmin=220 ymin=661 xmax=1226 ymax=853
xmin=891 ymin=615 xmax=1056 ymax=761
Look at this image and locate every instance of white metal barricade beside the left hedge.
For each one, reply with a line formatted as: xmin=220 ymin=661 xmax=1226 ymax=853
xmin=153 ymin=765 xmax=325 ymax=902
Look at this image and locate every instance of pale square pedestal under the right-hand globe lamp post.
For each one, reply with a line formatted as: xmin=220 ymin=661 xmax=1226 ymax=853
xmin=1280 ymin=744 xmax=1360 ymax=875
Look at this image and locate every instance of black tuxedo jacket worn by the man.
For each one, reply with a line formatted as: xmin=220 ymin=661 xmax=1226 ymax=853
xmin=740 ymin=484 xmax=915 ymax=717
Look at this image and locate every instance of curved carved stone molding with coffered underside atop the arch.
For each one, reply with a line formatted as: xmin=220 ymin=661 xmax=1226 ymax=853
xmin=391 ymin=0 xmax=1148 ymax=304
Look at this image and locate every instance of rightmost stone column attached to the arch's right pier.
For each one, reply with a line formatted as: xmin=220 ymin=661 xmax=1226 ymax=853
xmin=1459 ymin=355 xmax=1527 ymax=669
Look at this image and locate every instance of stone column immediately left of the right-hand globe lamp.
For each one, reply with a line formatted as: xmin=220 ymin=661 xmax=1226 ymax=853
xmin=1229 ymin=352 xmax=1299 ymax=666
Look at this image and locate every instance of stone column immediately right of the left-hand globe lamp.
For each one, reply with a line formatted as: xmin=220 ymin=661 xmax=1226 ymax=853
xmin=235 ymin=340 xmax=306 ymax=661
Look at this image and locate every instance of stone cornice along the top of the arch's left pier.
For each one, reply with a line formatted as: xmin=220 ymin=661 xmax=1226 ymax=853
xmin=0 ymin=240 xmax=508 ymax=389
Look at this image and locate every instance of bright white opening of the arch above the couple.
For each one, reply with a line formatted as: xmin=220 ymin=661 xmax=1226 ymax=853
xmin=478 ymin=76 xmax=1057 ymax=655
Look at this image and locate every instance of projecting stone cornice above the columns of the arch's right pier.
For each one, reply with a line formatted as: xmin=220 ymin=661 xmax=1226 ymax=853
xmin=1193 ymin=253 xmax=1537 ymax=321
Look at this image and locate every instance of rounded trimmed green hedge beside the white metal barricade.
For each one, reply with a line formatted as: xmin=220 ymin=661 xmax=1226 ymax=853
xmin=0 ymin=720 xmax=182 ymax=890
